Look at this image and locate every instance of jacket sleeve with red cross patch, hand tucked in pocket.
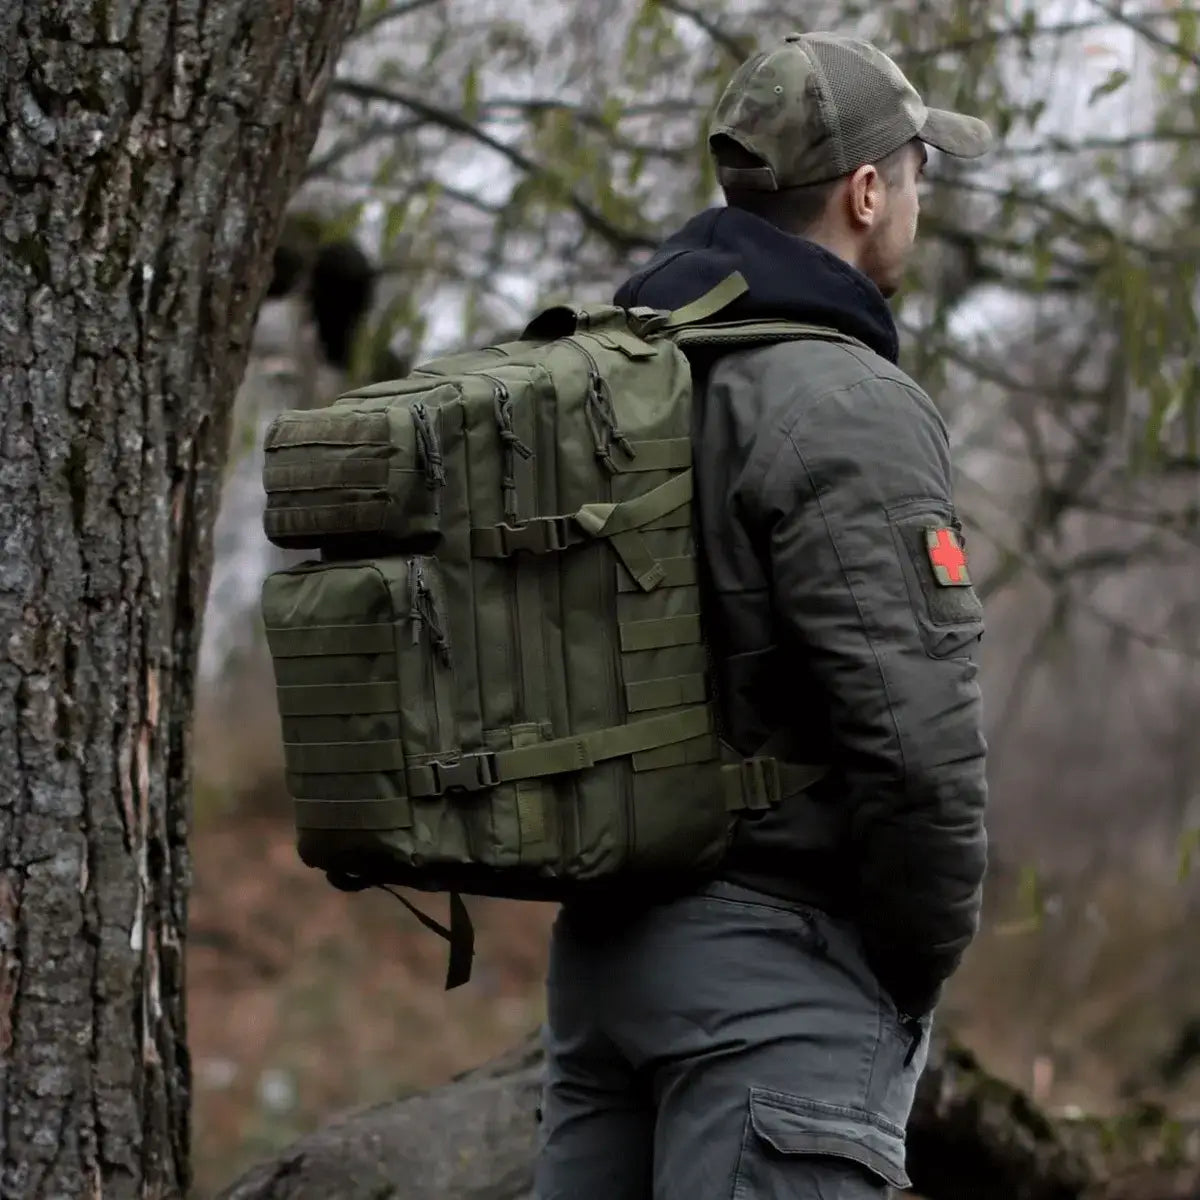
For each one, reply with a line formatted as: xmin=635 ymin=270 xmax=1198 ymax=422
xmin=754 ymin=377 xmax=986 ymax=1016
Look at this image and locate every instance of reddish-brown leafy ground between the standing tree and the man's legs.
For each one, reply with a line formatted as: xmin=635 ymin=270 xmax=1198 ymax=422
xmin=188 ymin=817 xmax=553 ymax=1198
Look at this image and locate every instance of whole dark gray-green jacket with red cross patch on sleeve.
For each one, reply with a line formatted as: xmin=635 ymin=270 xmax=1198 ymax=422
xmin=695 ymin=342 xmax=986 ymax=1013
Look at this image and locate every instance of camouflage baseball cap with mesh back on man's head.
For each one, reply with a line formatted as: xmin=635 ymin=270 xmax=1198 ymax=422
xmin=709 ymin=34 xmax=991 ymax=192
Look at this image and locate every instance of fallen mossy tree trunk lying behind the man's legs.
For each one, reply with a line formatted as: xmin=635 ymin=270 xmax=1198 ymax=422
xmin=218 ymin=1039 xmax=1200 ymax=1200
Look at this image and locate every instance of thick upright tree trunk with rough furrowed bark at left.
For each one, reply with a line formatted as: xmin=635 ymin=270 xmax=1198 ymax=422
xmin=0 ymin=0 xmax=358 ymax=1200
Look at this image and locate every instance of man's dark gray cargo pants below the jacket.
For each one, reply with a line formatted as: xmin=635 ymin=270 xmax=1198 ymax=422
xmin=535 ymin=883 xmax=929 ymax=1200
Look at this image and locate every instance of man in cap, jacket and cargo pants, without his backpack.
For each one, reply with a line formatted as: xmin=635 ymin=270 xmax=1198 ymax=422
xmin=536 ymin=34 xmax=990 ymax=1200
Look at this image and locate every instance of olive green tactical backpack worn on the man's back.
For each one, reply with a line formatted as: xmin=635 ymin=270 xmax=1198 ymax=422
xmin=262 ymin=275 xmax=848 ymax=986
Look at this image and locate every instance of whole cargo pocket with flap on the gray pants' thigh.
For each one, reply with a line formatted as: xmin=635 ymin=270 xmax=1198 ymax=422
xmin=732 ymin=1087 xmax=912 ymax=1200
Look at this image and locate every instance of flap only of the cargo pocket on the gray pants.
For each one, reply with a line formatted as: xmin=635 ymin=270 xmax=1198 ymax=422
xmin=750 ymin=1087 xmax=912 ymax=1189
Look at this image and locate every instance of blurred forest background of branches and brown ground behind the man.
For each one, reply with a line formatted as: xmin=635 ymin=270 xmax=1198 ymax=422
xmin=188 ymin=0 xmax=1200 ymax=1196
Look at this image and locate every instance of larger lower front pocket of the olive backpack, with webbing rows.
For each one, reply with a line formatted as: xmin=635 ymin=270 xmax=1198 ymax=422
xmin=263 ymin=557 xmax=469 ymax=878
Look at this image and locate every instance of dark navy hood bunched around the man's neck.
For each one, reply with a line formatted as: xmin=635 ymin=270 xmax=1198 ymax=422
xmin=613 ymin=208 xmax=899 ymax=362
